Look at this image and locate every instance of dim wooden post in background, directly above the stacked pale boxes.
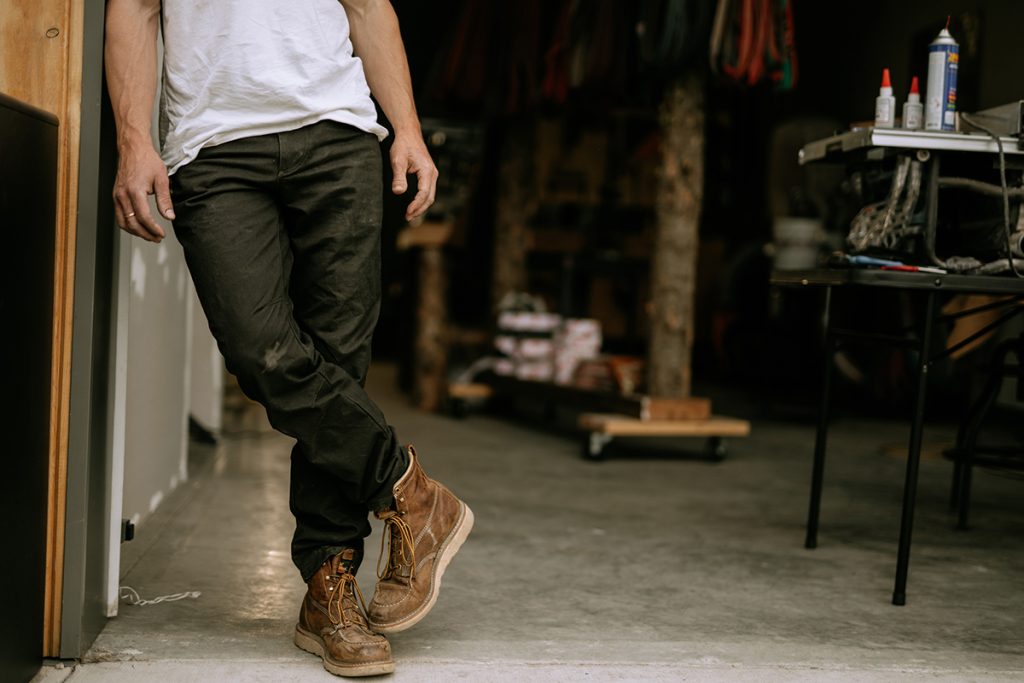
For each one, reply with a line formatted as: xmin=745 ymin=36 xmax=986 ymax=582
xmin=492 ymin=122 xmax=536 ymax=309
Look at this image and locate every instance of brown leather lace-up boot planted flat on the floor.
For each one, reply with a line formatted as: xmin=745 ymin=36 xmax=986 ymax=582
xmin=295 ymin=550 xmax=394 ymax=676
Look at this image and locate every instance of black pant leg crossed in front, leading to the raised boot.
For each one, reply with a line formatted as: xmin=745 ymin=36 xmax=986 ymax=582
xmin=172 ymin=126 xmax=400 ymax=578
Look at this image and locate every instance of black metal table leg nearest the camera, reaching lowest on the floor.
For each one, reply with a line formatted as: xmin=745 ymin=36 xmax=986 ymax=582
xmin=893 ymin=292 xmax=935 ymax=605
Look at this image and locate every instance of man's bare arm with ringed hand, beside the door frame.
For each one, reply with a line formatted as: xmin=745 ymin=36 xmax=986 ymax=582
xmin=104 ymin=0 xmax=174 ymax=242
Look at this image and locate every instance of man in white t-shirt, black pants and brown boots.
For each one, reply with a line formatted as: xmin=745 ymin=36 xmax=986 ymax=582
xmin=105 ymin=0 xmax=473 ymax=676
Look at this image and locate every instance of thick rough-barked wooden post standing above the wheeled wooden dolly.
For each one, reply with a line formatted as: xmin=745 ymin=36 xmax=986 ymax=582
xmin=647 ymin=73 xmax=705 ymax=398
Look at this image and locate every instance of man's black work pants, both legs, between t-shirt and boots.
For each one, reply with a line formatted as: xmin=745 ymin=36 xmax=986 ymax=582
xmin=171 ymin=122 xmax=409 ymax=580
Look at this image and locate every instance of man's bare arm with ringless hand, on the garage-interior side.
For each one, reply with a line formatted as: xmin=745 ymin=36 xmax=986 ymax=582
xmin=340 ymin=0 xmax=437 ymax=220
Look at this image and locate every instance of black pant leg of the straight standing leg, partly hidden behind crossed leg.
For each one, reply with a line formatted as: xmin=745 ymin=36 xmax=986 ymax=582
xmin=280 ymin=121 xmax=408 ymax=577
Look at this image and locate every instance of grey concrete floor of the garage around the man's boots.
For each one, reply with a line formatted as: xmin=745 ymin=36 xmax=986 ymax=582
xmin=32 ymin=368 xmax=1024 ymax=683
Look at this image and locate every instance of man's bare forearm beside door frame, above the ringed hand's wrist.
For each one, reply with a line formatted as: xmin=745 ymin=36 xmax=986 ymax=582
xmin=104 ymin=0 xmax=160 ymax=150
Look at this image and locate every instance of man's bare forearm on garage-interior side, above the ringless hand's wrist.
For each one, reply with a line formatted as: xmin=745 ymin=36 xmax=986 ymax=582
xmin=342 ymin=0 xmax=420 ymax=136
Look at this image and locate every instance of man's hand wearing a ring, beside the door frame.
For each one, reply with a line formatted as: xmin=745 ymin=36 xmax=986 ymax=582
xmin=114 ymin=142 xmax=174 ymax=242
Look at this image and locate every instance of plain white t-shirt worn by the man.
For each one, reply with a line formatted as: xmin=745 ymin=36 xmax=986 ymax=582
xmin=160 ymin=0 xmax=387 ymax=173
